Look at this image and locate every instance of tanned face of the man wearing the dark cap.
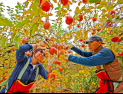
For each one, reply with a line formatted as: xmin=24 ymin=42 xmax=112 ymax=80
xmin=88 ymin=41 xmax=101 ymax=52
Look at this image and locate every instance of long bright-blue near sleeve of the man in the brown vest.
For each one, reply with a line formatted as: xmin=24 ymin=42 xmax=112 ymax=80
xmin=68 ymin=49 xmax=115 ymax=66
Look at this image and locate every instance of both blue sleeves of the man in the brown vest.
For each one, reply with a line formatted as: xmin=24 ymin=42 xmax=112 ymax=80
xmin=68 ymin=47 xmax=115 ymax=67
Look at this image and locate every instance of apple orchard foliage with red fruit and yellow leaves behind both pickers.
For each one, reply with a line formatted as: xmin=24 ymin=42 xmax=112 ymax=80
xmin=0 ymin=0 xmax=123 ymax=93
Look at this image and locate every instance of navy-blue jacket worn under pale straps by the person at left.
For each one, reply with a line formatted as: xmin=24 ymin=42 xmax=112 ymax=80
xmin=0 ymin=43 xmax=48 ymax=93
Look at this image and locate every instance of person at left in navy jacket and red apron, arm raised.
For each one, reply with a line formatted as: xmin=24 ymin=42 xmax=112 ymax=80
xmin=0 ymin=40 xmax=55 ymax=93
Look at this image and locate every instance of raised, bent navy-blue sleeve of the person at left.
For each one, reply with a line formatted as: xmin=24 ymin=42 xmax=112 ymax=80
xmin=16 ymin=43 xmax=33 ymax=63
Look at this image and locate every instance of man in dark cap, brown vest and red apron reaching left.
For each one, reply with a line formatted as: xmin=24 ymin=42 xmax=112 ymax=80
xmin=64 ymin=35 xmax=123 ymax=93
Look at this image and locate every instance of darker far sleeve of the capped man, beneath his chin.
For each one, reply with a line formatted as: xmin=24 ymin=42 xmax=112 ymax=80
xmin=71 ymin=47 xmax=92 ymax=57
